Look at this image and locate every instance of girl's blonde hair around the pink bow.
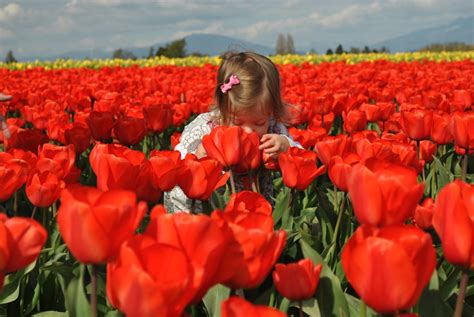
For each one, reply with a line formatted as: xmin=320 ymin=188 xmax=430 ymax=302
xmin=214 ymin=52 xmax=286 ymax=124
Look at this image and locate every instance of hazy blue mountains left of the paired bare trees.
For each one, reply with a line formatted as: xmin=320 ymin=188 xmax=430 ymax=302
xmin=19 ymin=34 xmax=275 ymax=61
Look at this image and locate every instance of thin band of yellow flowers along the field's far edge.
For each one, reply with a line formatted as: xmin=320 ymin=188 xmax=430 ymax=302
xmin=0 ymin=51 xmax=474 ymax=70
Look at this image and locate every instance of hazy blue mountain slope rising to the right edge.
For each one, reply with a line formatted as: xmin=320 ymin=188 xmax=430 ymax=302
xmin=370 ymin=16 xmax=474 ymax=53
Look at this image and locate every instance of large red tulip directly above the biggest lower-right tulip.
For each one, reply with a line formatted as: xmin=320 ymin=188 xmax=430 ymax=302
xmin=347 ymin=159 xmax=424 ymax=226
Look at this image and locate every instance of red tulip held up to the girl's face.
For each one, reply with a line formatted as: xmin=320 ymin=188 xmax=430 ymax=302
xmin=202 ymin=126 xmax=261 ymax=172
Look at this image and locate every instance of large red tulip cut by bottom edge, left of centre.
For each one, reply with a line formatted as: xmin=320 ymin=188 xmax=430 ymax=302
xmin=106 ymin=236 xmax=192 ymax=317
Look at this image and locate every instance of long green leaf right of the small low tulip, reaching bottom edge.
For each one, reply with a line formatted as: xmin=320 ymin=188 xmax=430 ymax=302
xmin=300 ymin=240 xmax=349 ymax=317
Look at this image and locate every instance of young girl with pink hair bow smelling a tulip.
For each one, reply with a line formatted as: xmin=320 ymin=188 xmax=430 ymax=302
xmin=164 ymin=52 xmax=301 ymax=212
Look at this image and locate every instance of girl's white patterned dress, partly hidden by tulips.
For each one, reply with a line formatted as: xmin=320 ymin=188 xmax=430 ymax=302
xmin=164 ymin=112 xmax=302 ymax=212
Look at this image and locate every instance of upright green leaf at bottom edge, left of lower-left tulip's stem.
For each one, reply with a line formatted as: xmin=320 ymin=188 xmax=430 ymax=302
xmin=66 ymin=264 xmax=90 ymax=317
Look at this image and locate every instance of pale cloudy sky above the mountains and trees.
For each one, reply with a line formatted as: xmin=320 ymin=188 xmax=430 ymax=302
xmin=0 ymin=0 xmax=474 ymax=59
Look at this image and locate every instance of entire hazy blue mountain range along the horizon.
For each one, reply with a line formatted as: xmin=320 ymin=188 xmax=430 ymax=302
xmin=18 ymin=16 xmax=474 ymax=61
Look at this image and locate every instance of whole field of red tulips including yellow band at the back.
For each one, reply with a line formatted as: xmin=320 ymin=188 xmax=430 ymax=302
xmin=0 ymin=52 xmax=474 ymax=317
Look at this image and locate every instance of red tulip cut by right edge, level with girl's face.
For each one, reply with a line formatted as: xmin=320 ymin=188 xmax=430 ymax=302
xmin=450 ymin=111 xmax=474 ymax=150
